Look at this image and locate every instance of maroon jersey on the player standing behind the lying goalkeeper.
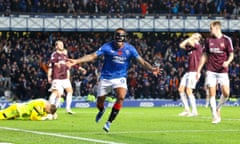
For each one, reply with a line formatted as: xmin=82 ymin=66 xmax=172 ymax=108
xmin=49 ymin=52 xmax=68 ymax=79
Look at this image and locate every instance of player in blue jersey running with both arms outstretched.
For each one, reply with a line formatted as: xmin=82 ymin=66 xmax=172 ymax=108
xmin=69 ymin=28 xmax=160 ymax=132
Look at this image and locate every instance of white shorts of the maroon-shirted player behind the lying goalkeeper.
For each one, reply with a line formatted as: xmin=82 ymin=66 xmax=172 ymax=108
xmin=49 ymin=79 xmax=72 ymax=94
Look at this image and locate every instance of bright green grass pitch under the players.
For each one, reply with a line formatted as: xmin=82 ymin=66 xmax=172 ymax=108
xmin=0 ymin=106 xmax=240 ymax=144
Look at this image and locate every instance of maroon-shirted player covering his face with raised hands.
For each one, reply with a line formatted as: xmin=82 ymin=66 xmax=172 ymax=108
xmin=178 ymin=33 xmax=203 ymax=116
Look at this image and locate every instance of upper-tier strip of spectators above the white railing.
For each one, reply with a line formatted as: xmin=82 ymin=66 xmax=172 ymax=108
xmin=0 ymin=0 xmax=240 ymax=18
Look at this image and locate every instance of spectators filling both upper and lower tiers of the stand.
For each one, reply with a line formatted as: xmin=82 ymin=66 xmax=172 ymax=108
xmin=0 ymin=0 xmax=240 ymax=101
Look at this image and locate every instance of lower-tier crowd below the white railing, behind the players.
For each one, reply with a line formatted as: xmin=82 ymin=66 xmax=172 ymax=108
xmin=0 ymin=32 xmax=240 ymax=100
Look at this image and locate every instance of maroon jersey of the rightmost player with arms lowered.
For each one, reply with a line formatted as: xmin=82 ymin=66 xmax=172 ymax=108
xmin=204 ymin=35 xmax=233 ymax=73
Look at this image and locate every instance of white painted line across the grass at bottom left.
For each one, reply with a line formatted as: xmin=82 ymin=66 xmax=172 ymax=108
xmin=0 ymin=127 xmax=123 ymax=144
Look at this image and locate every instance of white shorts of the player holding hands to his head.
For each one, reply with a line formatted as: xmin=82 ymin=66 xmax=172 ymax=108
xmin=180 ymin=72 xmax=198 ymax=89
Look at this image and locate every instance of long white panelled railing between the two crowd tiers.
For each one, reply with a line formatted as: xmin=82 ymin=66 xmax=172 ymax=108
xmin=0 ymin=14 xmax=240 ymax=32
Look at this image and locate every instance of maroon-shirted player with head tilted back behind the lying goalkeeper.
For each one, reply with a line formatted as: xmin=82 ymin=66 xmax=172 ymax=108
xmin=48 ymin=40 xmax=86 ymax=114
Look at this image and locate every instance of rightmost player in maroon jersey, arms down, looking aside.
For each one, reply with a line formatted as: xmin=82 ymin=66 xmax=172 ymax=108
xmin=198 ymin=21 xmax=234 ymax=124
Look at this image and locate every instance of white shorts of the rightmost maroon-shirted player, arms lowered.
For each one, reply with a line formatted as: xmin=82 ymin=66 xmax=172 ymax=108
xmin=205 ymin=71 xmax=230 ymax=87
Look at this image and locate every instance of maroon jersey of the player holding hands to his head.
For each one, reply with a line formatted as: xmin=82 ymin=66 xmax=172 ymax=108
xmin=188 ymin=44 xmax=203 ymax=72
